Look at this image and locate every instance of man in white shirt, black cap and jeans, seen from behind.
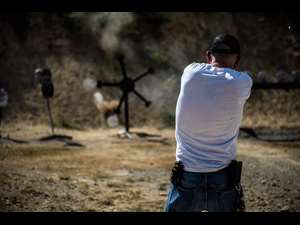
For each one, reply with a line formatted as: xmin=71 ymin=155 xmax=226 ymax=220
xmin=166 ymin=34 xmax=253 ymax=212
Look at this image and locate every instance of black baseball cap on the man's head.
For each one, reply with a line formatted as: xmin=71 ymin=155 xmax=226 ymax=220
xmin=208 ymin=34 xmax=241 ymax=55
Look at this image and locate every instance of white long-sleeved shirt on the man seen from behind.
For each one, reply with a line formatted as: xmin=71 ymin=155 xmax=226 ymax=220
xmin=176 ymin=63 xmax=253 ymax=173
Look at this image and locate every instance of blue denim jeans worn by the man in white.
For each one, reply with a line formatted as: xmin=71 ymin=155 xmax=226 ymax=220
xmin=165 ymin=171 xmax=236 ymax=212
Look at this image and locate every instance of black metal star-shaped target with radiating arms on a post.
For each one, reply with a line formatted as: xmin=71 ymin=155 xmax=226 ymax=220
xmin=97 ymin=55 xmax=154 ymax=133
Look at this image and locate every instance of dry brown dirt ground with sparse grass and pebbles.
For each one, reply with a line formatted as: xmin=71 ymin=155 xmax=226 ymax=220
xmin=0 ymin=126 xmax=300 ymax=212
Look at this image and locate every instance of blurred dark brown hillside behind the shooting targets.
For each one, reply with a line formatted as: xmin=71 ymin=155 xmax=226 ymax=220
xmin=0 ymin=12 xmax=300 ymax=128
